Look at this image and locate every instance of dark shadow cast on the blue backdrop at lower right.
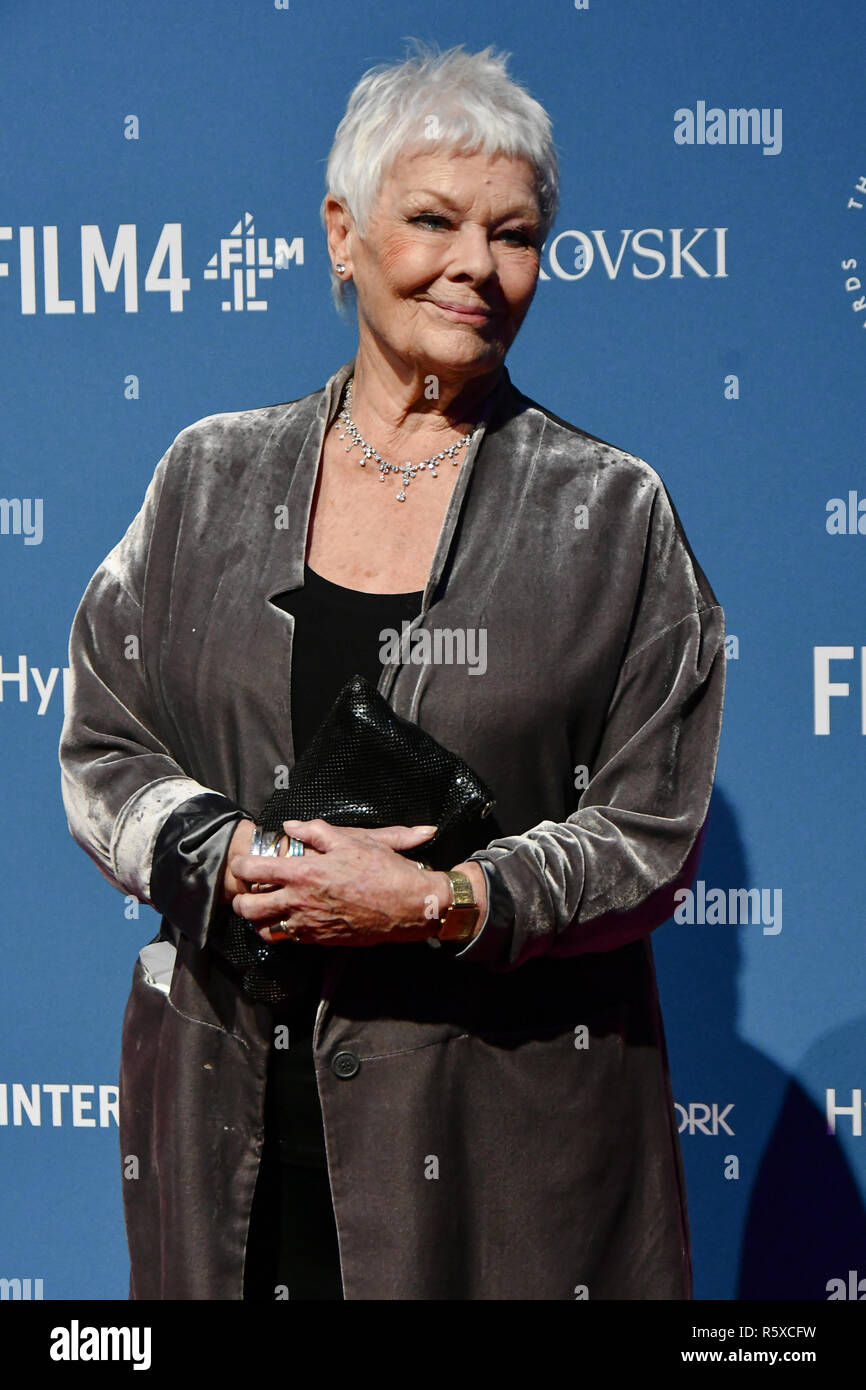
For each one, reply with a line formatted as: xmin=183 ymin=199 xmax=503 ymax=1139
xmin=653 ymin=787 xmax=866 ymax=1300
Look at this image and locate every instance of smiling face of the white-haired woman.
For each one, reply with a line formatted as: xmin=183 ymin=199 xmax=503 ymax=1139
xmin=346 ymin=150 xmax=541 ymax=379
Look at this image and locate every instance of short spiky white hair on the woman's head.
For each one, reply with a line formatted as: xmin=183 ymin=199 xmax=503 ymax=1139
xmin=321 ymin=39 xmax=559 ymax=313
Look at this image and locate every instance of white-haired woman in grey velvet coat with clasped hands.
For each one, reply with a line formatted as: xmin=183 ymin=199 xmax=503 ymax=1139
xmin=61 ymin=47 xmax=724 ymax=1300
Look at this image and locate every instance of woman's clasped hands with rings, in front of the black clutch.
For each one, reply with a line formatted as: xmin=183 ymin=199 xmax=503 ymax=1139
xmin=224 ymin=820 xmax=469 ymax=945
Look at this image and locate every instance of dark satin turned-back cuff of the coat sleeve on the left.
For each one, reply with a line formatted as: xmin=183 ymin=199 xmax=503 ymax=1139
xmin=150 ymin=791 xmax=248 ymax=947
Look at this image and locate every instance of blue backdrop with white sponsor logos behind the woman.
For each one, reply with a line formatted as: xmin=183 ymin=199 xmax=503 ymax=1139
xmin=0 ymin=0 xmax=866 ymax=1300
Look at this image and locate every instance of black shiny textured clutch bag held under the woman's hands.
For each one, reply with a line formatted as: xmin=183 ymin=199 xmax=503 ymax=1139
xmin=209 ymin=676 xmax=493 ymax=1004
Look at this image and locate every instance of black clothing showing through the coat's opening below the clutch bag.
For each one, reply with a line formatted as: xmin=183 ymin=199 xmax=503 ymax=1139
xmin=243 ymin=994 xmax=343 ymax=1302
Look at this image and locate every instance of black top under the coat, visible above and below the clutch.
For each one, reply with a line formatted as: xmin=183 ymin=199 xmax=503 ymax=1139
xmin=265 ymin=564 xmax=424 ymax=1168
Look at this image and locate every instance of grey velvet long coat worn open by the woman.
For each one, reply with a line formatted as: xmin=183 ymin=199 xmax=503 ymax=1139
xmin=61 ymin=363 xmax=724 ymax=1300
